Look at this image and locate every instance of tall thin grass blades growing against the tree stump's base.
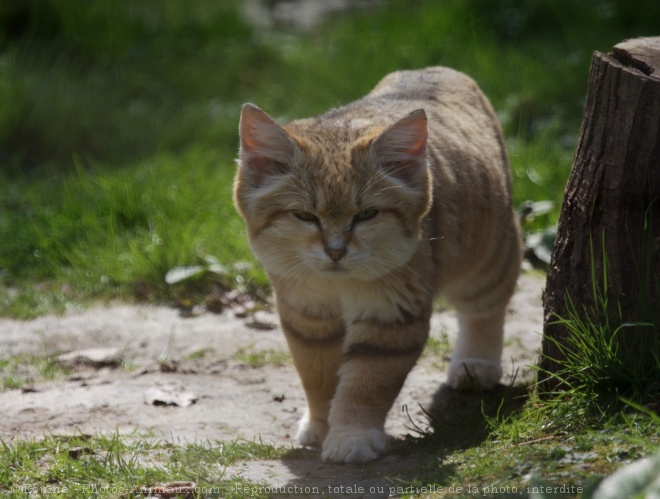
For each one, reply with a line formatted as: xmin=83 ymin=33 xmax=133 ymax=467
xmin=546 ymin=226 xmax=660 ymax=424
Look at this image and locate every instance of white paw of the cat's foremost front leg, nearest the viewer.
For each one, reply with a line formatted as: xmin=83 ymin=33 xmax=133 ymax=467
xmin=321 ymin=426 xmax=387 ymax=463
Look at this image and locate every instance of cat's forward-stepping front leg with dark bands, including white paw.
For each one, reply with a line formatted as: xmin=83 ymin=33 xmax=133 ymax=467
xmin=322 ymin=314 xmax=428 ymax=463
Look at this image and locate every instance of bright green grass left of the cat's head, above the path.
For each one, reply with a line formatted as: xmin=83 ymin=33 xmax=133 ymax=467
xmin=0 ymin=149 xmax=263 ymax=317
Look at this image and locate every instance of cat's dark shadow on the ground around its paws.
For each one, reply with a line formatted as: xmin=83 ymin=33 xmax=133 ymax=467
xmin=272 ymin=385 xmax=528 ymax=498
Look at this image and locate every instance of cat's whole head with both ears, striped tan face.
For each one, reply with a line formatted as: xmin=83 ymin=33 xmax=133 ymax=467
xmin=234 ymin=104 xmax=432 ymax=280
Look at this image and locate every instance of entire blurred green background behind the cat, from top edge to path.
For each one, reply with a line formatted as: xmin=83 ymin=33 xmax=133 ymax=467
xmin=0 ymin=0 xmax=660 ymax=315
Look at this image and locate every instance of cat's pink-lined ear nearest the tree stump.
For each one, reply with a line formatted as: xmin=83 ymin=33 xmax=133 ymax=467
xmin=371 ymin=109 xmax=428 ymax=185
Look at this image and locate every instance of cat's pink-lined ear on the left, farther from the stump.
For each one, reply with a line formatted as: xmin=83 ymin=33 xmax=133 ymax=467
xmin=239 ymin=104 xmax=296 ymax=187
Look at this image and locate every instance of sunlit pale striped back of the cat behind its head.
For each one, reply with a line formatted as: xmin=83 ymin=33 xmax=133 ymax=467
xmin=320 ymin=66 xmax=511 ymax=184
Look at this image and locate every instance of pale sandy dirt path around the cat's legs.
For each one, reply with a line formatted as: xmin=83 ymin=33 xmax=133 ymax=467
xmin=0 ymin=274 xmax=544 ymax=497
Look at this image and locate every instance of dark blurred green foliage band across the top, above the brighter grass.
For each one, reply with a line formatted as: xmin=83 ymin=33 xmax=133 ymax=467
xmin=0 ymin=0 xmax=660 ymax=175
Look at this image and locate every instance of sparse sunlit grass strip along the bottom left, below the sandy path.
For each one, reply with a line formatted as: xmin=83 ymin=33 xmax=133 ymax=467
xmin=0 ymin=434 xmax=284 ymax=498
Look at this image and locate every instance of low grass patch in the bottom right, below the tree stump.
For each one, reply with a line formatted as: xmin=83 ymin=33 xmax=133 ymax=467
xmin=392 ymin=389 xmax=660 ymax=498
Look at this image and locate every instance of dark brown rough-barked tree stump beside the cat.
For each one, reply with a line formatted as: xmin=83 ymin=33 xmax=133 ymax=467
xmin=539 ymin=37 xmax=660 ymax=391
